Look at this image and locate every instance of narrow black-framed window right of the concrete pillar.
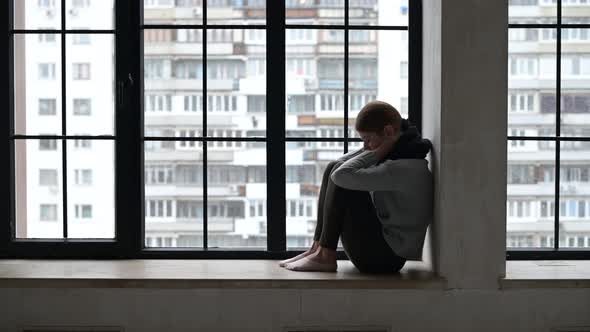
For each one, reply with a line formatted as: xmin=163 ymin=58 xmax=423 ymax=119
xmin=506 ymin=0 xmax=590 ymax=259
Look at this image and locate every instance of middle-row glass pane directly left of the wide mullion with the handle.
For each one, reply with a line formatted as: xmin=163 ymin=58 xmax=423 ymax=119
xmin=66 ymin=34 xmax=115 ymax=135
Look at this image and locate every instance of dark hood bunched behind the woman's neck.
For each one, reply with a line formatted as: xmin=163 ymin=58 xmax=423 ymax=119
xmin=386 ymin=119 xmax=432 ymax=160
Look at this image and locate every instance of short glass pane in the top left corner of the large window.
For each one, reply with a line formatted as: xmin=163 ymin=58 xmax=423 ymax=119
xmin=13 ymin=0 xmax=61 ymax=29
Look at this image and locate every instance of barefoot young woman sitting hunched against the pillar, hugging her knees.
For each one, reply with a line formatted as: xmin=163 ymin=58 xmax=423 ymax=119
xmin=280 ymin=101 xmax=433 ymax=273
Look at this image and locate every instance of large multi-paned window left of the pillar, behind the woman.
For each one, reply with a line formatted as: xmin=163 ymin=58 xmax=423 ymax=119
xmin=0 ymin=0 xmax=420 ymax=258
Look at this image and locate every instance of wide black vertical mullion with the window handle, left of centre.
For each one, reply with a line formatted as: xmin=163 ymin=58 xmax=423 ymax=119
xmin=115 ymin=0 xmax=145 ymax=257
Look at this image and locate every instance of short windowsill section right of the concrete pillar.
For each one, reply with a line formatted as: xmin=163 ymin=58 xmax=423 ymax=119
xmin=500 ymin=260 xmax=590 ymax=289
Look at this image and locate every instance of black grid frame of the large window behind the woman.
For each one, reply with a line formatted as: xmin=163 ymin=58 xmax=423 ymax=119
xmin=0 ymin=0 xmax=422 ymax=259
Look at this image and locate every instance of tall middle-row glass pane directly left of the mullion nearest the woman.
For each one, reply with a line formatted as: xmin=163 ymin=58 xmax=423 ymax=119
xmin=207 ymin=29 xmax=266 ymax=137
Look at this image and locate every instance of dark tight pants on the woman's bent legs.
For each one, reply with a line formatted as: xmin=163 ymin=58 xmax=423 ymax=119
xmin=314 ymin=161 xmax=406 ymax=273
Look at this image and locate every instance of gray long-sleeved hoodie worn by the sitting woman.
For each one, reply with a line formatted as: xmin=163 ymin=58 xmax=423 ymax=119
xmin=331 ymin=149 xmax=434 ymax=260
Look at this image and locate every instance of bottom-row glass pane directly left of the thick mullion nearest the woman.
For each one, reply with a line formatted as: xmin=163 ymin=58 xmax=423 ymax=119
xmin=207 ymin=142 xmax=267 ymax=248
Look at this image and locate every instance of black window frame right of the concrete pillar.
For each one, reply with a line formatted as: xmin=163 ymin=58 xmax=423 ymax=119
xmin=506 ymin=0 xmax=590 ymax=260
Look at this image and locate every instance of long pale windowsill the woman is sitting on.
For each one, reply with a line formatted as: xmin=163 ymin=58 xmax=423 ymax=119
xmin=0 ymin=260 xmax=446 ymax=289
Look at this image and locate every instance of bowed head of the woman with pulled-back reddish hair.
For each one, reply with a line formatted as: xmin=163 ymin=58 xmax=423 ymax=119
xmin=354 ymin=101 xmax=402 ymax=150
